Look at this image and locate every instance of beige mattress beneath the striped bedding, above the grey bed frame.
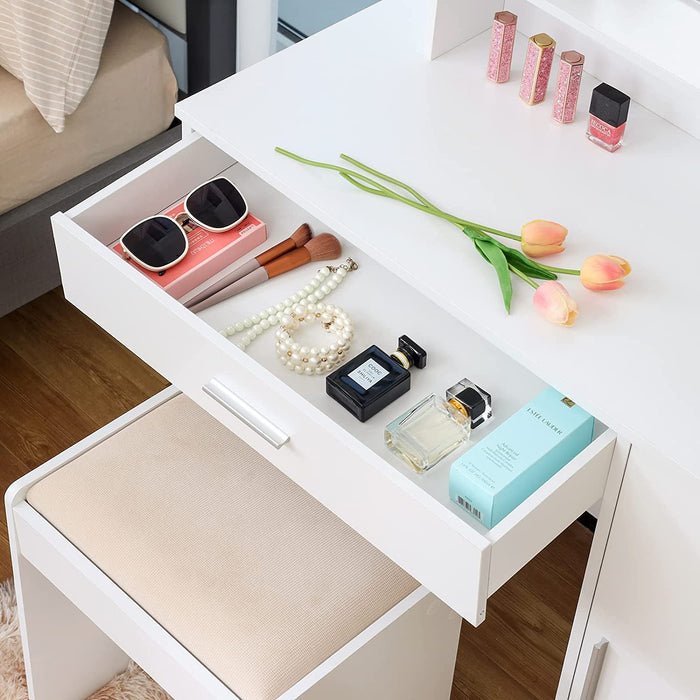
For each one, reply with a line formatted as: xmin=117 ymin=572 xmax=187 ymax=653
xmin=0 ymin=3 xmax=177 ymax=214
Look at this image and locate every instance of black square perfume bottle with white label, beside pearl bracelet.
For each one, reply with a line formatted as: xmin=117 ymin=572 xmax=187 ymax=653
xmin=326 ymin=335 xmax=427 ymax=423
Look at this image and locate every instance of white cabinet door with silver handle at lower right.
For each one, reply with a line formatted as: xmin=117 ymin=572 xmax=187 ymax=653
xmin=570 ymin=445 xmax=700 ymax=700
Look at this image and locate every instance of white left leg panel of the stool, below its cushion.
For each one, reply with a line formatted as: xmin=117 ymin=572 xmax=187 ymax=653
xmin=15 ymin=555 xmax=129 ymax=700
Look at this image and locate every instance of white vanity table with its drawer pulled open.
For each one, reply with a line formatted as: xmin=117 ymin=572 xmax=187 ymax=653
xmin=49 ymin=0 xmax=700 ymax=700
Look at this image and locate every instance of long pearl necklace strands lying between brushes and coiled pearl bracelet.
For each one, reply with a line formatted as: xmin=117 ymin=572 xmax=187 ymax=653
xmin=219 ymin=258 xmax=357 ymax=350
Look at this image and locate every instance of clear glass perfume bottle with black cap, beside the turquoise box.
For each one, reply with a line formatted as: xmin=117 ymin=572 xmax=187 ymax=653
xmin=384 ymin=379 xmax=492 ymax=473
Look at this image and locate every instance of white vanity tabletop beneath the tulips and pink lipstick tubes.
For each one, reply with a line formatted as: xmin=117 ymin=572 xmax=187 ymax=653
xmin=176 ymin=0 xmax=700 ymax=476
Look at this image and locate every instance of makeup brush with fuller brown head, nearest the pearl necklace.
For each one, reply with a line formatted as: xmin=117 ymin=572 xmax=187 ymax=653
xmin=190 ymin=233 xmax=342 ymax=313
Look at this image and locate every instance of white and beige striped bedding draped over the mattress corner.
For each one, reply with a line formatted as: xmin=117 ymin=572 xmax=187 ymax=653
xmin=0 ymin=0 xmax=114 ymax=133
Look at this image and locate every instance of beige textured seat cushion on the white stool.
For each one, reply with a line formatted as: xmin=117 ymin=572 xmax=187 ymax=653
xmin=27 ymin=395 xmax=418 ymax=700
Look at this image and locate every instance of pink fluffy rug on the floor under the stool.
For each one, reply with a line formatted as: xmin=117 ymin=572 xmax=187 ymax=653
xmin=0 ymin=581 xmax=172 ymax=700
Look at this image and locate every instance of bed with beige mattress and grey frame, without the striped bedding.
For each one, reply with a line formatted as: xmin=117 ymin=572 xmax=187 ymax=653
xmin=0 ymin=2 xmax=196 ymax=316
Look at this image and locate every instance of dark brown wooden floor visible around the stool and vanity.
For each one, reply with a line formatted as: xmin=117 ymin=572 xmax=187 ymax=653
xmin=0 ymin=289 xmax=592 ymax=700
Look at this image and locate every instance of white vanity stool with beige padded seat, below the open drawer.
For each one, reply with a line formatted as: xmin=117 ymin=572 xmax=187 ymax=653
xmin=6 ymin=388 xmax=461 ymax=700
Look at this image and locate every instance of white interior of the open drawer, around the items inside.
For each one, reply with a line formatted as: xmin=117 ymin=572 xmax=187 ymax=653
xmin=68 ymin=139 xmax=606 ymax=542
